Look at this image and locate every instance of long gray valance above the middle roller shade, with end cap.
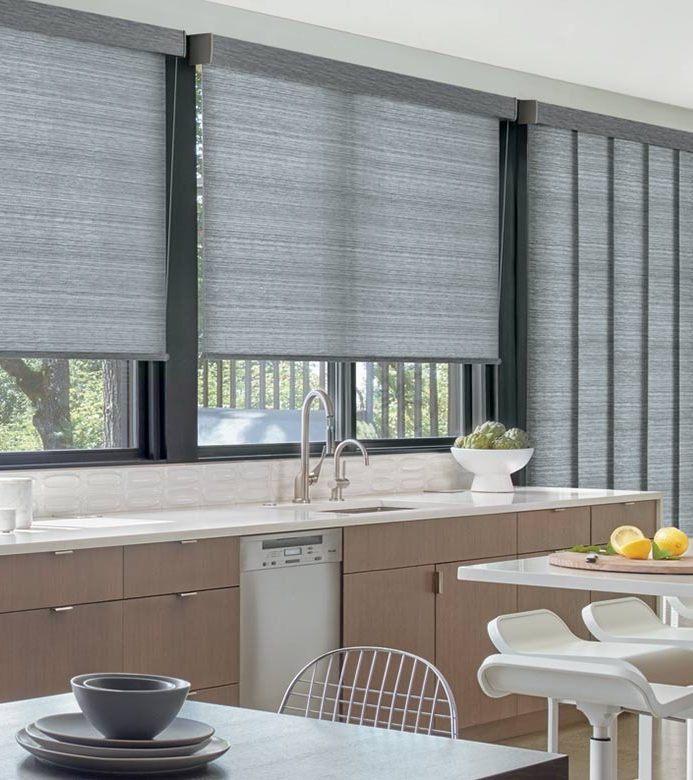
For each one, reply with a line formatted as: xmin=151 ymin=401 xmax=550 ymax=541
xmin=189 ymin=33 xmax=517 ymax=120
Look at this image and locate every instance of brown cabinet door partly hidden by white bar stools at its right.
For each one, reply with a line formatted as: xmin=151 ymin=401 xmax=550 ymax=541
xmin=435 ymin=561 xmax=517 ymax=728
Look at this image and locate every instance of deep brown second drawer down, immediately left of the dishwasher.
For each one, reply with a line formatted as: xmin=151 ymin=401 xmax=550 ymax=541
xmin=123 ymin=588 xmax=239 ymax=690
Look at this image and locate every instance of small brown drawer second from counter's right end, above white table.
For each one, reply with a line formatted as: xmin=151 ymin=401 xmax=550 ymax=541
xmin=517 ymin=506 xmax=590 ymax=555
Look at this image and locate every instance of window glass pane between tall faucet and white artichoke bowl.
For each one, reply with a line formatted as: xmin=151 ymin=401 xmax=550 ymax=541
xmin=356 ymin=363 xmax=462 ymax=439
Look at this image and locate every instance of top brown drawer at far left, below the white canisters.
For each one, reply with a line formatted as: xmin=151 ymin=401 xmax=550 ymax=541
xmin=0 ymin=547 xmax=123 ymax=612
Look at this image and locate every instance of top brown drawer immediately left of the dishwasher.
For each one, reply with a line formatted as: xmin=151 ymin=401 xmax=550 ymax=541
xmin=124 ymin=538 xmax=238 ymax=598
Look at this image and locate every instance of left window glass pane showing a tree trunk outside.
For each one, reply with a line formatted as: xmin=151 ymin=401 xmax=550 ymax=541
xmin=0 ymin=358 xmax=136 ymax=452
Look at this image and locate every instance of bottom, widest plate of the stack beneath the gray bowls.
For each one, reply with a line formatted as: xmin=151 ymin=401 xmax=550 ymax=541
xmin=16 ymin=729 xmax=229 ymax=776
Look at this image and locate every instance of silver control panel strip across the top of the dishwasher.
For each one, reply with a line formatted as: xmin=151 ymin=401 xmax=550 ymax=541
xmin=241 ymin=528 xmax=342 ymax=571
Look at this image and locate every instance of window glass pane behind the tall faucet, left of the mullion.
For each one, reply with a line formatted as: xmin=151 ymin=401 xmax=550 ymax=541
xmin=197 ymin=360 xmax=327 ymax=446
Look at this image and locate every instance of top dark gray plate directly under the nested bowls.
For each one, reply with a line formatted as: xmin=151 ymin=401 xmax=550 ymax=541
xmin=34 ymin=712 xmax=214 ymax=748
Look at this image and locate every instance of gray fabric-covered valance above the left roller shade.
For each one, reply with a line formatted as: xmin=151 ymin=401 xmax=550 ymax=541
xmin=0 ymin=0 xmax=186 ymax=57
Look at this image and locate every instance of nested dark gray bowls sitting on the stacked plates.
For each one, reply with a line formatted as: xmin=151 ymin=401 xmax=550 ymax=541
xmin=70 ymin=672 xmax=190 ymax=739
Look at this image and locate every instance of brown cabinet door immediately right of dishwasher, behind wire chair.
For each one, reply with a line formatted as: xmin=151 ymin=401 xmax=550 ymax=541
xmin=342 ymin=566 xmax=435 ymax=661
